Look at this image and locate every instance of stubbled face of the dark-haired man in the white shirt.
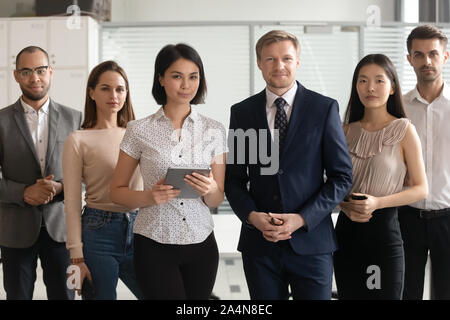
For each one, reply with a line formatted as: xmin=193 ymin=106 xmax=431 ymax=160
xmin=407 ymin=38 xmax=449 ymax=83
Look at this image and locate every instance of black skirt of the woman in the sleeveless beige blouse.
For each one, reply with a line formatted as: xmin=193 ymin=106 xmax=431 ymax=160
xmin=333 ymin=208 xmax=405 ymax=300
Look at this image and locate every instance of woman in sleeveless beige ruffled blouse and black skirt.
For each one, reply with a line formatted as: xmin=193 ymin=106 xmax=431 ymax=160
xmin=334 ymin=54 xmax=428 ymax=300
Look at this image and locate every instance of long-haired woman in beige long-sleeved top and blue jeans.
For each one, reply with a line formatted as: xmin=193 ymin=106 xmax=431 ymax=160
xmin=63 ymin=61 xmax=142 ymax=300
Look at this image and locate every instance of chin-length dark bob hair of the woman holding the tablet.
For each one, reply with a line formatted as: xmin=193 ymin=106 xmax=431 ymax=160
xmin=152 ymin=43 xmax=206 ymax=105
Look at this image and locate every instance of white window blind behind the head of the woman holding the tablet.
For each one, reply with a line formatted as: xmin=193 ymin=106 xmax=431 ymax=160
xmin=101 ymin=26 xmax=250 ymax=128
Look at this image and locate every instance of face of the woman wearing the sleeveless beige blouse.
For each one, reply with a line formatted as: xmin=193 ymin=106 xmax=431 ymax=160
xmin=356 ymin=63 xmax=394 ymax=108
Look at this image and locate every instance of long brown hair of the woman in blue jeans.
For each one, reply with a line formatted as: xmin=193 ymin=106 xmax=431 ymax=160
xmin=81 ymin=60 xmax=135 ymax=129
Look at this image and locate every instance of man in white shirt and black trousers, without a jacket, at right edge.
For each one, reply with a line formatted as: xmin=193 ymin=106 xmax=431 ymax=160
xmin=399 ymin=25 xmax=450 ymax=300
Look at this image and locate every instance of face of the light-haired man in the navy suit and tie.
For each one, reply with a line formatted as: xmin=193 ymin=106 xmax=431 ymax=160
xmin=258 ymin=40 xmax=300 ymax=96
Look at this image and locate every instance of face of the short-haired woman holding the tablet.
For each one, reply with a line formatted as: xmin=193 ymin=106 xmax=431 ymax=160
xmin=159 ymin=58 xmax=200 ymax=105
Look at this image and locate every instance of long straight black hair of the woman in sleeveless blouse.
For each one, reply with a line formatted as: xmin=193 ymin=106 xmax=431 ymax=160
xmin=344 ymin=54 xmax=406 ymax=124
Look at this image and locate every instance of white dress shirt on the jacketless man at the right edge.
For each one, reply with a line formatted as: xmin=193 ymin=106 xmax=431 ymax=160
xmin=404 ymin=83 xmax=450 ymax=210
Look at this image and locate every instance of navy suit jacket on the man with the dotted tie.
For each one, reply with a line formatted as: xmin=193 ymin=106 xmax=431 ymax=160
xmin=225 ymin=83 xmax=352 ymax=255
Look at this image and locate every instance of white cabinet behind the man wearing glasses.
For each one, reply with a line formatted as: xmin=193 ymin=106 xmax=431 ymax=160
xmin=0 ymin=17 xmax=100 ymax=111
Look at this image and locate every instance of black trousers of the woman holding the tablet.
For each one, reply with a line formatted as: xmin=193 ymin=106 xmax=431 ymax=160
xmin=134 ymin=233 xmax=219 ymax=300
